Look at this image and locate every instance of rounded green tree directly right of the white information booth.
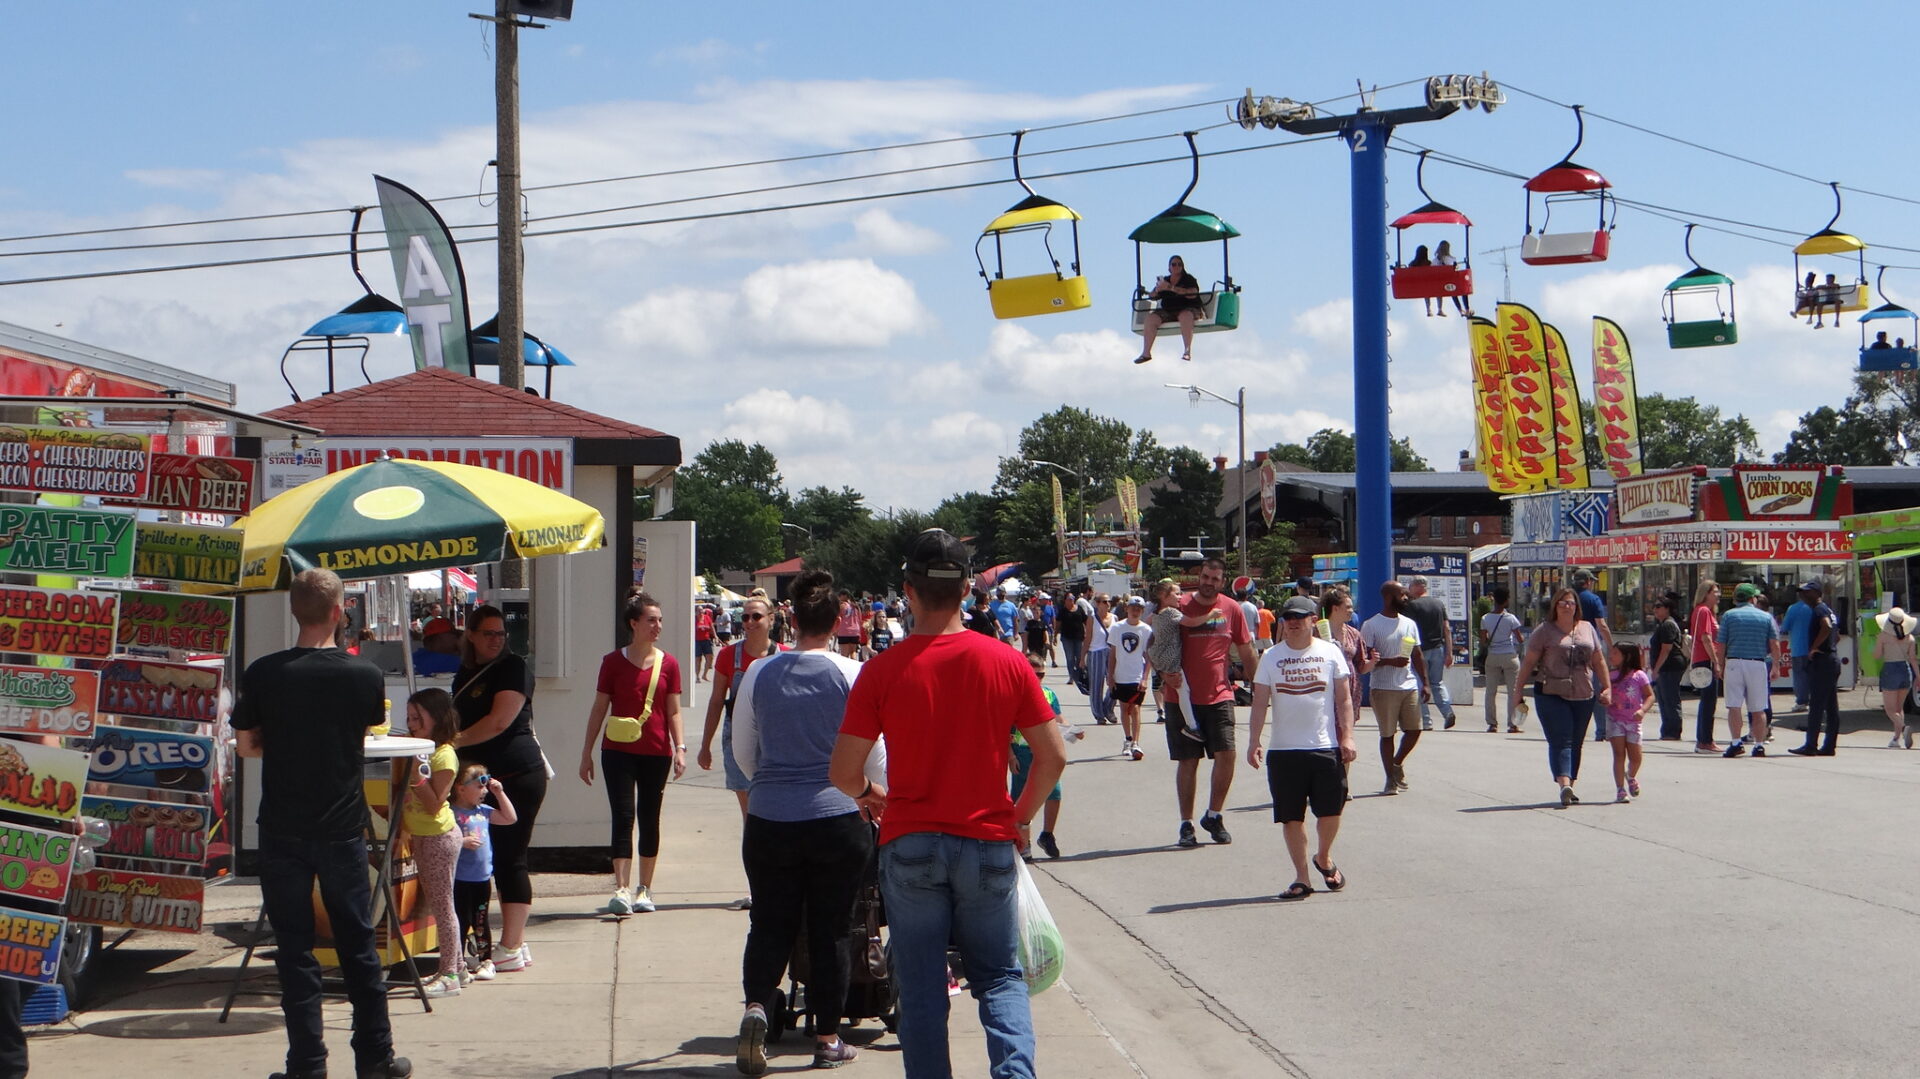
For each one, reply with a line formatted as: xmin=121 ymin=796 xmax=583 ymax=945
xmin=668 ymin=440 xmax=787 ymax=572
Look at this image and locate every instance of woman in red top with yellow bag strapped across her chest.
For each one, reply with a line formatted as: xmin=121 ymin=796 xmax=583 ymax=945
xmin=580 ymin=591 xmax=687 ymax=914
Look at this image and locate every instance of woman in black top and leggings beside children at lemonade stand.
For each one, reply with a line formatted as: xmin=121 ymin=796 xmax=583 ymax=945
xmin=453 ymin=605 xmax=547 ymax=971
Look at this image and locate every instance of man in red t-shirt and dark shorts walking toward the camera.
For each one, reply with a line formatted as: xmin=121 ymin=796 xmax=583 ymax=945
xmin=1167 ymin=559 xmax=1254 ymax=847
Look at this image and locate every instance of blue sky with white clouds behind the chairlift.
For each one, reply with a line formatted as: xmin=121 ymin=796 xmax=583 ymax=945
xmin=0 ymin=0 xmax=1920 ymax=507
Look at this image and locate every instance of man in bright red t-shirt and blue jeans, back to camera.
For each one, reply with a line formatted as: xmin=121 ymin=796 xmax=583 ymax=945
xmin=828 ymin=528 xmax=1068 ymax=1079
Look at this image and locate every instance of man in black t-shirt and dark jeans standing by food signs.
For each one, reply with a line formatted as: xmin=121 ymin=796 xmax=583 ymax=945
xmin=232 ymin=570 xmax=413 ymax=1079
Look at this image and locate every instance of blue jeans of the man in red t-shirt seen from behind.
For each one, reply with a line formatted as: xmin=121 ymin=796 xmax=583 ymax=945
xmin=879 ymin=831 xmax=1035 ymax=1079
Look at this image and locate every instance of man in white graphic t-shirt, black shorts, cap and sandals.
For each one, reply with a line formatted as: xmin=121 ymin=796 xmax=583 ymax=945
xmin=1246 ymin=595 xmax=1357 ymax=900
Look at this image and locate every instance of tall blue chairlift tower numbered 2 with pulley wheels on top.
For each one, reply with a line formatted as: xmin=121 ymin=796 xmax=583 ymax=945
xmin=1235 ymin=75 xmax=1507 ymax=614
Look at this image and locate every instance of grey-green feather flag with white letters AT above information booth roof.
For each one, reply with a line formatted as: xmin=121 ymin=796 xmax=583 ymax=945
xmin=372 ymin=177 xmax=472 ymax=374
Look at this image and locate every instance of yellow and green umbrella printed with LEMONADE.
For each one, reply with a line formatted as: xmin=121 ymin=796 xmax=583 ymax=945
xmin=240 ymin=459 xmax=607 ymax=591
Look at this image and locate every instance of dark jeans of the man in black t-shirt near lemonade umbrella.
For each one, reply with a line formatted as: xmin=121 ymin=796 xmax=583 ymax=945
xmin=259 ymin=831 xmax=394 ymax=1075
